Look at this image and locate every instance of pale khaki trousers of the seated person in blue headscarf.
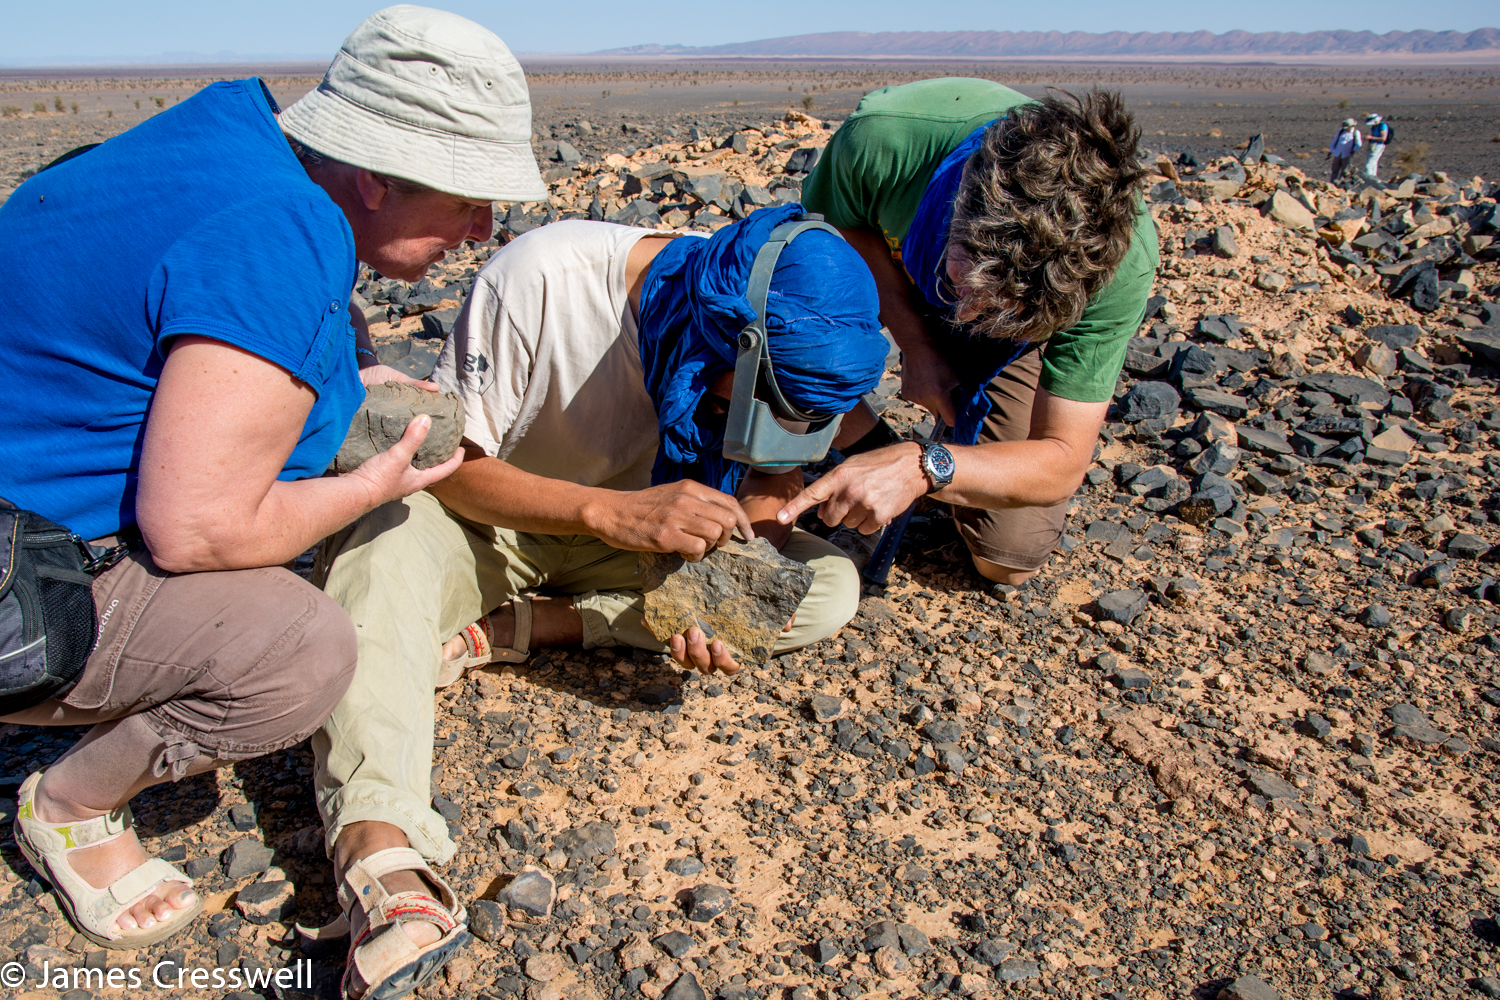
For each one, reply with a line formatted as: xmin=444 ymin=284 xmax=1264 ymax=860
xmin=312 ymin=493 xmax=860 ymax=862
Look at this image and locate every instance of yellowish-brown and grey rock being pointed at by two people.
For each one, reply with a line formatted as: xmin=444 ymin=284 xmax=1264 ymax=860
xmin=639 ymin=538 xmax=813 ymax=663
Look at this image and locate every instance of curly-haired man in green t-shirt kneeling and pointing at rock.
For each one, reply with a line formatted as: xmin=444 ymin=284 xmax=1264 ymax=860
xmin=779 ymin=78 xmax=1158 ymax=585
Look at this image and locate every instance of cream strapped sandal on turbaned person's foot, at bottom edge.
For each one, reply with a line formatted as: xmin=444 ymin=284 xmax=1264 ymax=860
xmin=297 ymin=847 xmax=473 ymax=1000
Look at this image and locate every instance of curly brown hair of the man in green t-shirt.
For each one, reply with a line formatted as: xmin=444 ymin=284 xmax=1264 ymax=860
xmin=948 ymin=90 xmax=1146 ymax=342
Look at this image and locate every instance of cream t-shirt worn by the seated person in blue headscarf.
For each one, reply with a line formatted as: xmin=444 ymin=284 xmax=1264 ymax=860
xmin=432 ymin=219 xmax=672 ymax=490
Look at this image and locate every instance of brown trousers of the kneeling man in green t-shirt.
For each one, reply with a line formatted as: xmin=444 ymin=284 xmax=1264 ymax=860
xmin=953 ymin=349 xmax=1068 ymax=570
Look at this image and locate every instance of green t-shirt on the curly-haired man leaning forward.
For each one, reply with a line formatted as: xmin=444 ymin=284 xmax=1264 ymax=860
xmin=803 ymin=76 xmax=1160 ymax=403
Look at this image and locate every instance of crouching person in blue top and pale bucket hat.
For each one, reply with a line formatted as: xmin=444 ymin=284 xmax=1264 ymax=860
xmin=0 ymin=6 xmax=546 ymax=977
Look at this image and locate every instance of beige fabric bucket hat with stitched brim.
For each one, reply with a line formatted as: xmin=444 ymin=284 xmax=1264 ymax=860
xmin=281 ymin=4 xmax=548 ymax=201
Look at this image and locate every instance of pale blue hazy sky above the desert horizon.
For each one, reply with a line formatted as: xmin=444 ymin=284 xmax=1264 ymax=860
xmin=0 ymin=0 xmax=1500 ymax=64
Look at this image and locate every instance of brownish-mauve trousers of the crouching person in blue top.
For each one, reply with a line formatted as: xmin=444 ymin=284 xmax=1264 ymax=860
xmin=5 ymin=552 xmax=356 ymax=778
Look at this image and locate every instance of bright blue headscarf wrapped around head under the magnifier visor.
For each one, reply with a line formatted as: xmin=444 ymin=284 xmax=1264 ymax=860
xmin=639 ymin=204 xmax=890 ymax=495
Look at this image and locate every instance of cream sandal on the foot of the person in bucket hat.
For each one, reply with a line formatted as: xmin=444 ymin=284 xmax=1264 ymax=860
xmin=15 ymin=771 xmax=203 ymax=951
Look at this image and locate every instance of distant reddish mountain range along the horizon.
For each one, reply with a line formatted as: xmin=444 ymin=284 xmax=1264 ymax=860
xmin=594 ymin=28 xmax=1500 ymax=60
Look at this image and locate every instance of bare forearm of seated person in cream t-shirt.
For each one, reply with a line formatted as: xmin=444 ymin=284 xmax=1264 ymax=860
xmin=429 ymin=442 xmax=617 ymax=535
